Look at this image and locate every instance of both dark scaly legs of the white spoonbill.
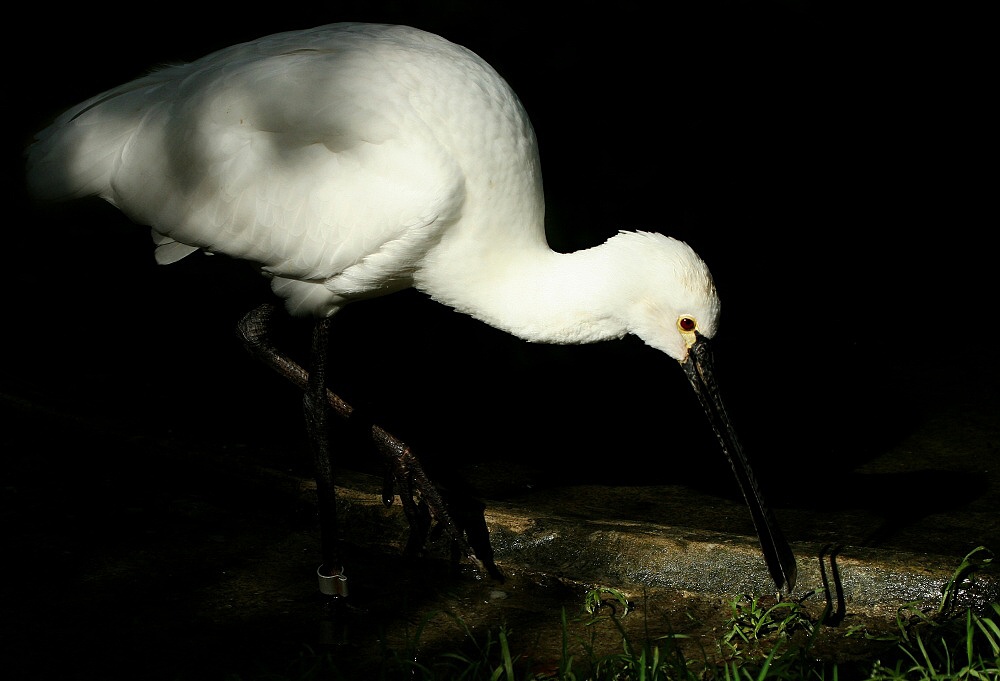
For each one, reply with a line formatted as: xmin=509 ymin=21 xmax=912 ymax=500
xmin=238 ymin=304 xmax=502 ymax=579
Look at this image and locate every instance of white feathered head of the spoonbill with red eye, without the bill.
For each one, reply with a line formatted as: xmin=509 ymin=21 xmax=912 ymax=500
xmin=613 ymin=232 xmax=720 ymax=364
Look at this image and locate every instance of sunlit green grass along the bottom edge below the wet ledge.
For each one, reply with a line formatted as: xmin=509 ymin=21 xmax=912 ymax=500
xmin=232 ymin=547 xmax=1000 ymax=681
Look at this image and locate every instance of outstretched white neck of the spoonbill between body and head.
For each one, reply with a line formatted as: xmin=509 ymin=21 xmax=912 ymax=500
xmin=416 ymin=242 xmax=627 ymax=344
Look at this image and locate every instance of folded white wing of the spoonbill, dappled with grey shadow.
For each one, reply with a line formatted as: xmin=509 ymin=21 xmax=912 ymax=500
xmin=29 ymin=24 xmax=463 ymax=281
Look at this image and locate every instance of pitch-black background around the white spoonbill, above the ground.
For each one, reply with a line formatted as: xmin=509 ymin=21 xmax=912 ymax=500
xmin=2 ymin=2 xmax=995 ymax=505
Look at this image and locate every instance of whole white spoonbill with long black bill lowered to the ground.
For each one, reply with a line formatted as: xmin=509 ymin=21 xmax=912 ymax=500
xmin=27 ymin=23 xmax=796 ymax=595
